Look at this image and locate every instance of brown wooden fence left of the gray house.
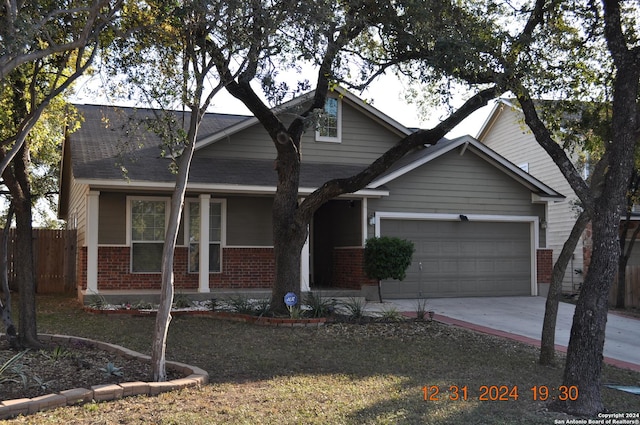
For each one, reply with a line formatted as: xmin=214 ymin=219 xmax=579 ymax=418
xmin=0 ymin=229 xmax=76 ymax=294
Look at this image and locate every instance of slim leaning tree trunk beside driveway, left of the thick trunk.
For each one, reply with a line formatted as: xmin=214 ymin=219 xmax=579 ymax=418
xmin=539 ymin=211 xmax=589 ymax=365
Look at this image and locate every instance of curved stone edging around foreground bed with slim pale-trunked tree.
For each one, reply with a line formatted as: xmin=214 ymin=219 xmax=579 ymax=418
xmin=0 ymin=334 xmax=209 ymax=419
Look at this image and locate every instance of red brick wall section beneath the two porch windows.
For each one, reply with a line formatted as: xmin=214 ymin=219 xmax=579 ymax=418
xmin=78 ymin=246 xmax=275 ymax=290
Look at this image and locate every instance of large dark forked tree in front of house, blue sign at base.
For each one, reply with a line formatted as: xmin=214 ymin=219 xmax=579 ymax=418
xmin=204 ymin=0 xmax=516 ymax=312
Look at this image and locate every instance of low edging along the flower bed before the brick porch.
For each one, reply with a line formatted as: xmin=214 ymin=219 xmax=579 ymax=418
xmin=84 ymin=307 xmax=327 ymax=327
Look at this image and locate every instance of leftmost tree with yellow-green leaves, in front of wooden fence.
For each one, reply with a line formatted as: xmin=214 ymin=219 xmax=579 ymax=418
xmin=0 ymin=0 xmax=122 ymax=347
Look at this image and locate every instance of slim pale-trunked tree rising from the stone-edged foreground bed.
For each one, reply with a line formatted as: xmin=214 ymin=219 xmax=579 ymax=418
xmin=100 ymin=0 xmax=253 ymax=381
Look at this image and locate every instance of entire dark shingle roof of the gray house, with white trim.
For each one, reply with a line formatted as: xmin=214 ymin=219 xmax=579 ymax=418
xmin=60 ymin=89 xmax=564 ymax=210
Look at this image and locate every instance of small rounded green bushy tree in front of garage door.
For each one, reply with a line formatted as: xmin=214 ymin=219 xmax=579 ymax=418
xmin=364 ymin=236 xmax=415 ymax=302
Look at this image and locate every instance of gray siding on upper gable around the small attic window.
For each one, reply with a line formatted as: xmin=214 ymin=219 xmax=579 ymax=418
xmin=196 ymin=101 xmax=400 ymax=164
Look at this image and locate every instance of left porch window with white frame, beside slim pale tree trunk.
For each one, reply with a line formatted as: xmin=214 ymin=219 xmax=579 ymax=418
xmin=130 ymin=199 xmax=167 ymax=273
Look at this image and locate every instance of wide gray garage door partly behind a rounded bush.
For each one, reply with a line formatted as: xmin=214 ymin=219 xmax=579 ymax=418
xmin=380 ymin=219 xmax=531 ymax=298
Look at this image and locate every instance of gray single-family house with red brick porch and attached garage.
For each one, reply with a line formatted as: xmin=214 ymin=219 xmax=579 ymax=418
xmin=59 ymin=90 xmax=564 ymax=299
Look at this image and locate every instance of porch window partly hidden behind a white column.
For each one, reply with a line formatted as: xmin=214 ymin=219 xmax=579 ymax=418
xmin=188 ymin=201 xmax=222 ymax=273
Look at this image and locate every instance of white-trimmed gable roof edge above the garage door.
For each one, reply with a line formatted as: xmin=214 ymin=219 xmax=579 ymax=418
xmin=367 ymin=136 xmax=565 ymax=200
